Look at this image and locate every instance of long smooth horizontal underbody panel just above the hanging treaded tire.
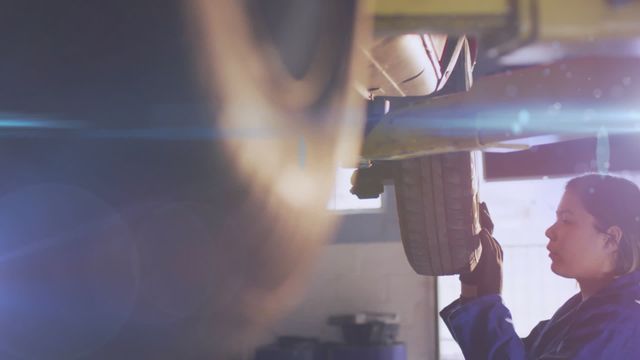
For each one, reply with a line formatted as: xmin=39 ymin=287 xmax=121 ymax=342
xmin=362 ymin=58 xmax=640 ymax=160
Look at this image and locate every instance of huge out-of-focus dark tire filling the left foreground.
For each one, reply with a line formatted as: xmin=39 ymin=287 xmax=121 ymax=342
xmin=0 ymin=0 xmax=368 ymax=360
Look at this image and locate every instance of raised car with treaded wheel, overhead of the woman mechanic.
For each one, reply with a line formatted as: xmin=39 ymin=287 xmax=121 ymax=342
xmin=352 ymin=1 xmax=640 ymax=275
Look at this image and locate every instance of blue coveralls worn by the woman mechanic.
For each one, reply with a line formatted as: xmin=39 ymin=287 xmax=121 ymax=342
xmin=440 ymin=271 xmax=640 ymax=360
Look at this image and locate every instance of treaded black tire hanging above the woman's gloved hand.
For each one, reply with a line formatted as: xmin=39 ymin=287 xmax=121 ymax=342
xmin=394 ymin=152 xmax=480 ymax=276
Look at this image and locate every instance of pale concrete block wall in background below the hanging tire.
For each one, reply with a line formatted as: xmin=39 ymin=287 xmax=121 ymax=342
xmin=262 ymin=241 xmax=437 ymax=360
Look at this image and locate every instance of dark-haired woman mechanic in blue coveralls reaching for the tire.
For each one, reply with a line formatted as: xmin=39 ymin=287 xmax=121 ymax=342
xmin=440 ymin=174 xmax=640 ymax=360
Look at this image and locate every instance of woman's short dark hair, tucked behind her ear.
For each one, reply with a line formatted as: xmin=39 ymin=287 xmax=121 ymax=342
xmin=565 ymin=174 xmax=640 ymax=275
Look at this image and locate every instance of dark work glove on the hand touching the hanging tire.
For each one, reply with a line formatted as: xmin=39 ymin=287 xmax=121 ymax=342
xmin=460 ymin=202 xmax=502 ymax=299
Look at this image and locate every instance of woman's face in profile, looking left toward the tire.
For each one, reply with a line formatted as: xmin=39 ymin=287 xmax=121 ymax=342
xmin=545 ymin=190 xmax=615 ymax=280
